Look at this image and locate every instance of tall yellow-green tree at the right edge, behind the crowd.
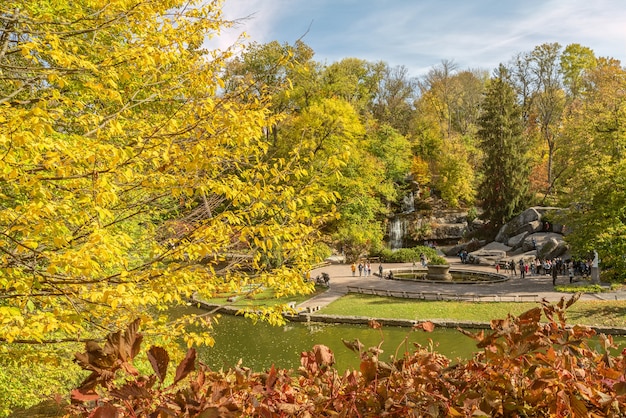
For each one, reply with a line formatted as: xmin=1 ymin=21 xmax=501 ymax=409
xmin=557 ymin=59 xmax=626 ymax=279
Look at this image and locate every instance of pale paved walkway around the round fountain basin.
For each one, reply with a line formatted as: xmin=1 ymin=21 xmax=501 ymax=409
xmin=298 ymin=257 xmax=626 ymax=309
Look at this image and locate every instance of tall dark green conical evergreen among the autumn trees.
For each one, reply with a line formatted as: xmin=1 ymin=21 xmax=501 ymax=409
xmin=478 ymin=66 xmax=529 ymax=227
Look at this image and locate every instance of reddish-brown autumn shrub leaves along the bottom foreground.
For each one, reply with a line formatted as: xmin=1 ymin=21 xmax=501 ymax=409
xmin=72 ymin=296 xmax=626 ymax=417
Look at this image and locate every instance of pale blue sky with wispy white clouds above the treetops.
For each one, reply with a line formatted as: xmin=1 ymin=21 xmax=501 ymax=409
xmin=214 ymin=0 xmax=626 ymax=77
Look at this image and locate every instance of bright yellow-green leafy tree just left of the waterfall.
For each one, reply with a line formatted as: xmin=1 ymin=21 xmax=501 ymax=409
xmin=281 ymin=98 xmax=394 ymax=257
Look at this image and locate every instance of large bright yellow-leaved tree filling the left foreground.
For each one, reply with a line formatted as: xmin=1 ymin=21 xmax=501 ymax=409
xmin=0 ymin=0 xmax=333 ymax=404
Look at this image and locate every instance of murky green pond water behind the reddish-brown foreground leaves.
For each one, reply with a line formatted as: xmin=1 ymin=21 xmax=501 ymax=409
xmin=198 ymin=315 xmax=476 ymax=371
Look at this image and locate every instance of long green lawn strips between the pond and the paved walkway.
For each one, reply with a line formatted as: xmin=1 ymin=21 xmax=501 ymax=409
xmin=319 ymin=295 xmax=626 ymax=327
